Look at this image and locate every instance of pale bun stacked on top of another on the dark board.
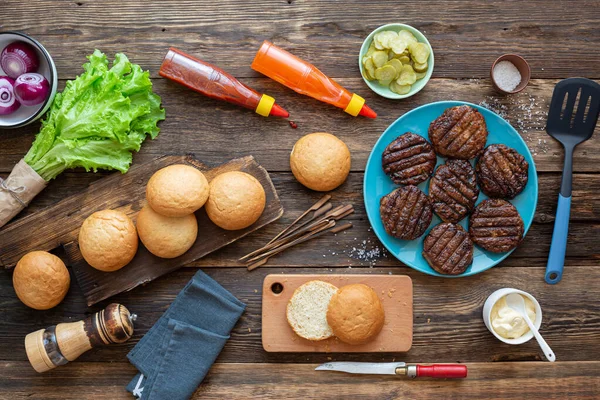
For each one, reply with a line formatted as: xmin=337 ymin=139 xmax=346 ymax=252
xmin=146 ymin=164 xmax=209 ymax=217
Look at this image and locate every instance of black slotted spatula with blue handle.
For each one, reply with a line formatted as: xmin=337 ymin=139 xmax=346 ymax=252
xmin=546 ymin=78 xmax=600 ymax=284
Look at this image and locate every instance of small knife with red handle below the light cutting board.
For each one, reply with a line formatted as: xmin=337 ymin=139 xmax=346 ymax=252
xmin=315 ymin=361 xmax=467 ymax=379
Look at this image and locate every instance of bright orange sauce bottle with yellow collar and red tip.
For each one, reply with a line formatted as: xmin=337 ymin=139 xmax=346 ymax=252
xmin=252 ymin=40 xmax=377 ymax=118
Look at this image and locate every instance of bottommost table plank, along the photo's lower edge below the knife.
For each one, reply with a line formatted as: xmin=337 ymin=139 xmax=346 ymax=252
xmin=0 ymin=360 xmax=600 ymax=400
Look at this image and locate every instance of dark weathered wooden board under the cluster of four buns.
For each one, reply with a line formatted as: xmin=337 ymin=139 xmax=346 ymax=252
xmin=0 ymin=155 xmax=283 ymax=305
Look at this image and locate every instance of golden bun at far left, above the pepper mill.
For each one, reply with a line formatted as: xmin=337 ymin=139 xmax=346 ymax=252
xmin=13 ymin=251 xmax=71 ymax=310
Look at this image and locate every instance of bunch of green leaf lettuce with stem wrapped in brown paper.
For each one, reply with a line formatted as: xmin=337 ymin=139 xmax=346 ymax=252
xmin=0 ymin=50 xmax=165 ymax=227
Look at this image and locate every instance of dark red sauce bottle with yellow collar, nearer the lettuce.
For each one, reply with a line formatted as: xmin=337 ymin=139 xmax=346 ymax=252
xmin=159 ymin=48 xmax=290 ymax=118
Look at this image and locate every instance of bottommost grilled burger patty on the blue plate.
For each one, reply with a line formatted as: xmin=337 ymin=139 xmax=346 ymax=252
xmin=423 ymin=222 xmax=473 ymax=275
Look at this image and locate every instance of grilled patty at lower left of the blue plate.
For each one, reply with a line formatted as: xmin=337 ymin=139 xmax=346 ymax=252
xmin=379 ymin=185 xmax=433 ymax=240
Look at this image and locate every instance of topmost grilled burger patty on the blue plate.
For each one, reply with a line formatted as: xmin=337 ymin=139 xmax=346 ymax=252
xmin=429 ymin=106 xmax=487 ymax=160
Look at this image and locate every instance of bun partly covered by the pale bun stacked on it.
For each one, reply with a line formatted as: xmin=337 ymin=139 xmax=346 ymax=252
xmin=137 ymin=205 xmax=198 ymax=258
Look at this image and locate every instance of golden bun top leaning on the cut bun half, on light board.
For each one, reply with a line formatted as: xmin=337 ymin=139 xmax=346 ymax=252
xmin=327 ymin=283 xmax=385 ymax=344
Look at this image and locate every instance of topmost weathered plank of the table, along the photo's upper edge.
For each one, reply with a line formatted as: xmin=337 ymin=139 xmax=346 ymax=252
xmin=3 ymin=0 xmax=600 ymax=78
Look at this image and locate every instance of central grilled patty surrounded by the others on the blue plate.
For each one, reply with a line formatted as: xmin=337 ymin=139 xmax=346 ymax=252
xmin=429 ymin=160 xmax=479 ymax=223
